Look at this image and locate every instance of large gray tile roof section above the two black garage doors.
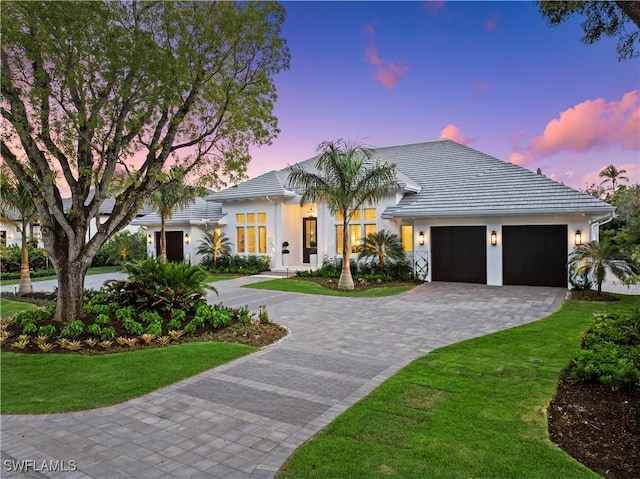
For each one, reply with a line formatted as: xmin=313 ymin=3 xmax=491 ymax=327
xmin=375 ymin=140 xmax=614 ymax=217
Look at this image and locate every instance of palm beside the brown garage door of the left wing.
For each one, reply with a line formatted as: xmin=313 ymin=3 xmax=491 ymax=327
xmin=150 ymin=168 xmax=204 ymax=261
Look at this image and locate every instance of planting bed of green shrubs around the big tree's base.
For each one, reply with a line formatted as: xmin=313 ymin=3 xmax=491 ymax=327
xmin=0 ymin=259 xmax=279 ymax=353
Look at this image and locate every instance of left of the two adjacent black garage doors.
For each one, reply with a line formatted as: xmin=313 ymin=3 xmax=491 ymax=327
xmin=431 ymin=226 xmax=487 ymax=284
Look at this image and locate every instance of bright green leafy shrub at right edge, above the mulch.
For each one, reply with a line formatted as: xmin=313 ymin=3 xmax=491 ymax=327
xmin=569 ymin=309 xmax=640 ymax=390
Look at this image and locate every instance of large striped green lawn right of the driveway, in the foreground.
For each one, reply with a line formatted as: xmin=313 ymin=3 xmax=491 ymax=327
xmin=279 ymin=296 xmax=640 ymax=479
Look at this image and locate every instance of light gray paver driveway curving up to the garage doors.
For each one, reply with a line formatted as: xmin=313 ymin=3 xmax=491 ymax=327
xmin=2 ymin=277 xmax=565 ymax=479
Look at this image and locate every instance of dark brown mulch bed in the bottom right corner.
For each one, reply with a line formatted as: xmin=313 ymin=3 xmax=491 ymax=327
xmin=548 ymin=371 xmax=640 ymax=479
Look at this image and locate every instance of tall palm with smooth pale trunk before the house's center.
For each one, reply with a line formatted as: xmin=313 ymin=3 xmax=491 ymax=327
xmin=289 ymin=140 xmax=396 ymax=289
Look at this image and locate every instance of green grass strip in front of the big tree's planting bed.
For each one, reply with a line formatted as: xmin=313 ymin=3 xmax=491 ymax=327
xmin=0 ymin=343 xmax=255 ymax=414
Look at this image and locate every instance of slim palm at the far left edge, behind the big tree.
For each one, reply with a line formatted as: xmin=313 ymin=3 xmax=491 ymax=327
xmin=0 ymin=172 xmax=38 ymax=294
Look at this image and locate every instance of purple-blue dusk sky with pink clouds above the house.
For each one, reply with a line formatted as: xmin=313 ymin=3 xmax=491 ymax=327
xmin=248 ymin=1 xmax=640 ymax=189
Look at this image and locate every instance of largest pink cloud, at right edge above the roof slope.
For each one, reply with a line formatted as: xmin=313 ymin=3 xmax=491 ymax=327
xmin=509 ymin=90 xmax=640 ymax=166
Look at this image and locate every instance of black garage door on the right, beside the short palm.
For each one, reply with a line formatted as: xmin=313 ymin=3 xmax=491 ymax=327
xmin=502 ymin=225 xmax=568 ymax=287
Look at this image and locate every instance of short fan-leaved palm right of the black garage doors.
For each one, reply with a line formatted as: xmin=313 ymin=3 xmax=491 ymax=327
xmin=569 ymin=239 xmax=638 ymax=296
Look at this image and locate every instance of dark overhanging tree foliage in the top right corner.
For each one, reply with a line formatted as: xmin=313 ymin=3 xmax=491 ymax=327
xmin=538 ymin=0 xmax=640 ymax=61
